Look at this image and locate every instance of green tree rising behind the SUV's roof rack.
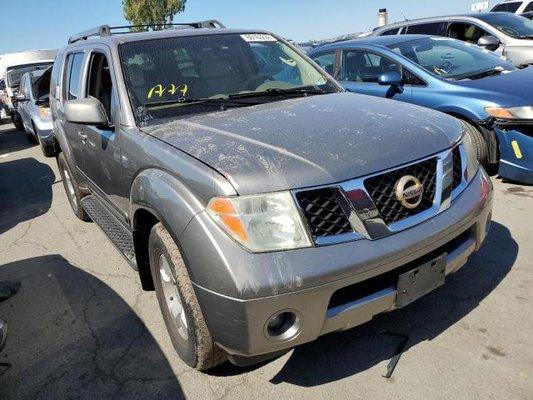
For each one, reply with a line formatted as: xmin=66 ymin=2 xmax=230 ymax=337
xmin=122 ymin=0 xmax=187 ymax=29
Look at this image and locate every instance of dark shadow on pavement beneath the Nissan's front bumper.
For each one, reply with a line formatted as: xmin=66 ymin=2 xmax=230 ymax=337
xmin=211 ymin=223 xmax=518 ymax=387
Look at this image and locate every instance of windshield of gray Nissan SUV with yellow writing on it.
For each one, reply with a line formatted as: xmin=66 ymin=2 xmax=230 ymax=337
xmin=120 ymin=33 xmax=339 ymax=124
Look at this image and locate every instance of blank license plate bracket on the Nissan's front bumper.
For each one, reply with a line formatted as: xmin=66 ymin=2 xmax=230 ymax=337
xmin=396 ymin=253 xmax=447 ymax=308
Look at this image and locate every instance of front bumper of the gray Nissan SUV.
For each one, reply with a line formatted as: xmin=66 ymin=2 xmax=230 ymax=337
xmin=180 ymin=169 xmax=492 ymax=364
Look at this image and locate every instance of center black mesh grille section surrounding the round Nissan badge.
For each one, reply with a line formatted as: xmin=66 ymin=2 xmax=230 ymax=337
xmin=364 ymin=158 xmax=437 ymax=224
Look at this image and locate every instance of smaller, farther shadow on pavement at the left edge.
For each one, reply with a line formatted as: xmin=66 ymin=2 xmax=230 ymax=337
xmin=0 ymin=158 xmax=56 ymax=234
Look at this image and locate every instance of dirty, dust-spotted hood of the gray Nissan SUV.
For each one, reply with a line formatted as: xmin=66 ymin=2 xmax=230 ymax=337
xmin=143 ymin=93 xmax=461 ymax=194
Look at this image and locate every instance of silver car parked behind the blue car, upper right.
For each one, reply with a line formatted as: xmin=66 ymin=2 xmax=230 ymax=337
xmin=372 ymin=12 xmax=533 ymax=66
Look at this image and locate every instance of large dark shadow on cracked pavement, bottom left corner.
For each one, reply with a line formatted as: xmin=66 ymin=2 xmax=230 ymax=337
xmin=0 ymin=255 xmax=185 ymax=400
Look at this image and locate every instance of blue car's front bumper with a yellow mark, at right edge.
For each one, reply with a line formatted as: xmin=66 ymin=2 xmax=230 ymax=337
xmin=495 ymin=125 xmax=533 ymax=185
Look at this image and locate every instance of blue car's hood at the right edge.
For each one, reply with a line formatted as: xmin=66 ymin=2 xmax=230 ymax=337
xmin=452 ymin=67 xmax=533 ymax=107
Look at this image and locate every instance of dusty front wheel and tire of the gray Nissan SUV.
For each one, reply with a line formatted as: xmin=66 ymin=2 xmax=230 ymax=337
xmin=148 ymin=223 xmax=226 ymax=371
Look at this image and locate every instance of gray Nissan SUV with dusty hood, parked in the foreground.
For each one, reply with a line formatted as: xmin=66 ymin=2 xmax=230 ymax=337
xmin=50 ymin=21 xmax=492 ymax=369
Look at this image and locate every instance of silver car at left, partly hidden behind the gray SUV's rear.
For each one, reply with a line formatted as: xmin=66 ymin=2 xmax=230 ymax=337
xmin=14 ymin=68 xmax=53 ymax=152
